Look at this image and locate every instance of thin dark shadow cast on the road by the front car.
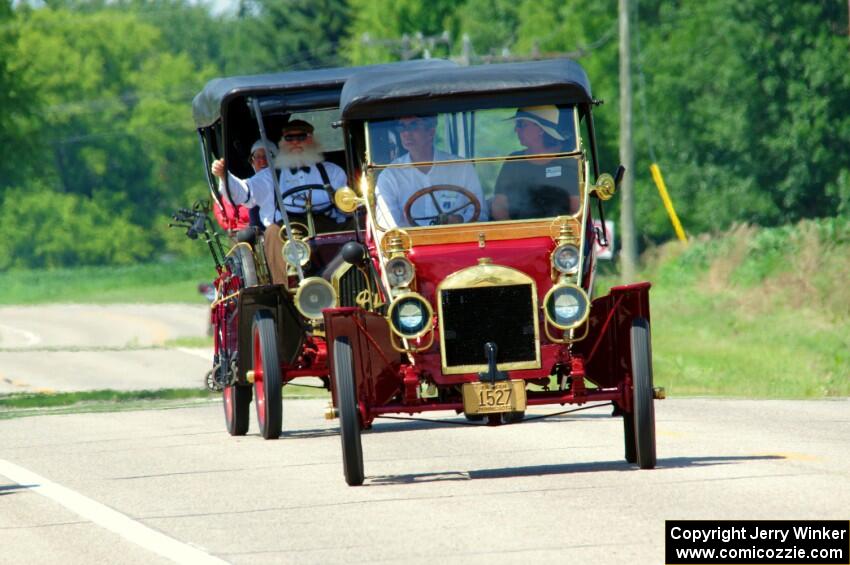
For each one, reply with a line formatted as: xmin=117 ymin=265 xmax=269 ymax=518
xmin=367 ymin=455 xmax=785 ymax=486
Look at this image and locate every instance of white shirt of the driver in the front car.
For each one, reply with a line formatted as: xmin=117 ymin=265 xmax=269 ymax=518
xmin=375 ymin=151 xmax=487 ymax=228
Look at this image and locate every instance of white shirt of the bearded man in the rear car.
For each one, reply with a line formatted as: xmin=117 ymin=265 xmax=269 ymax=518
xmin=224 ymin=161 xmax=346 ymax=226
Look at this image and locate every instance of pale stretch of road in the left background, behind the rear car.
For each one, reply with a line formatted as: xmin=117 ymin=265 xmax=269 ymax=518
xmin=0 ymin=304 xmax=212 ymax=394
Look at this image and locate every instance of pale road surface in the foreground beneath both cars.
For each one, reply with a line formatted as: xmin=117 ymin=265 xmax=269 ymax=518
xmin=0 ymin=399 xmax=850 ymax=565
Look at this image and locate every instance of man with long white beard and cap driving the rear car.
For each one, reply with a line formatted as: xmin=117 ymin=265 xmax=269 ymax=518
xmin=212 ymin=120 xmax=346 ymax=283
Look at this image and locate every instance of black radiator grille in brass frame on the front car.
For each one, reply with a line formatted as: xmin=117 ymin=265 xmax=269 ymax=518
xmin=440 ymin=284 xmax=537 ymax=367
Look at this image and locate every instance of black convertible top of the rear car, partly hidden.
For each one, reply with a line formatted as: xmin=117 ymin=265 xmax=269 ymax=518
xmin=192 ymin=59 xmax=455 ymax=129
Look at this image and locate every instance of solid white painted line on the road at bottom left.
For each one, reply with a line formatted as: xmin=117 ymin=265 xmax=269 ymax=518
xmin=0 ymin=459 xmax=227 ymax=565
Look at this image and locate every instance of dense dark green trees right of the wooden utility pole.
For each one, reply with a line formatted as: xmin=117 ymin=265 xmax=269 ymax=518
xmin=638 ymin=0 xmax=850 ymax=237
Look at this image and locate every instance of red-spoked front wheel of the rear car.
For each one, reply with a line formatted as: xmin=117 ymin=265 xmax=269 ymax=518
xmin=251 ymin=310 xmax=283 ymax=439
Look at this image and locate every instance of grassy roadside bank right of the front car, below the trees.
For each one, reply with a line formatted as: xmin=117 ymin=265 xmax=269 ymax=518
xmin=599 ymin=218 xmax=850 ymax=398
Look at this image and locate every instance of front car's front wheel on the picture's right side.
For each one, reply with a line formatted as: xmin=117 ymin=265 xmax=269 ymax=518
xmin=623 ymin=318 xmax=655 ymax=469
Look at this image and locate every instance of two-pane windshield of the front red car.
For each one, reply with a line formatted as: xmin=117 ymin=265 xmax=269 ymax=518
xmin=364 ymin=105 xmax=584 ymax=230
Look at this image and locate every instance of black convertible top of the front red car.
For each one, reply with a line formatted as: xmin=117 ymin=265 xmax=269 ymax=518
xmin=340 ymin=59 xmax=593 ymax=119
